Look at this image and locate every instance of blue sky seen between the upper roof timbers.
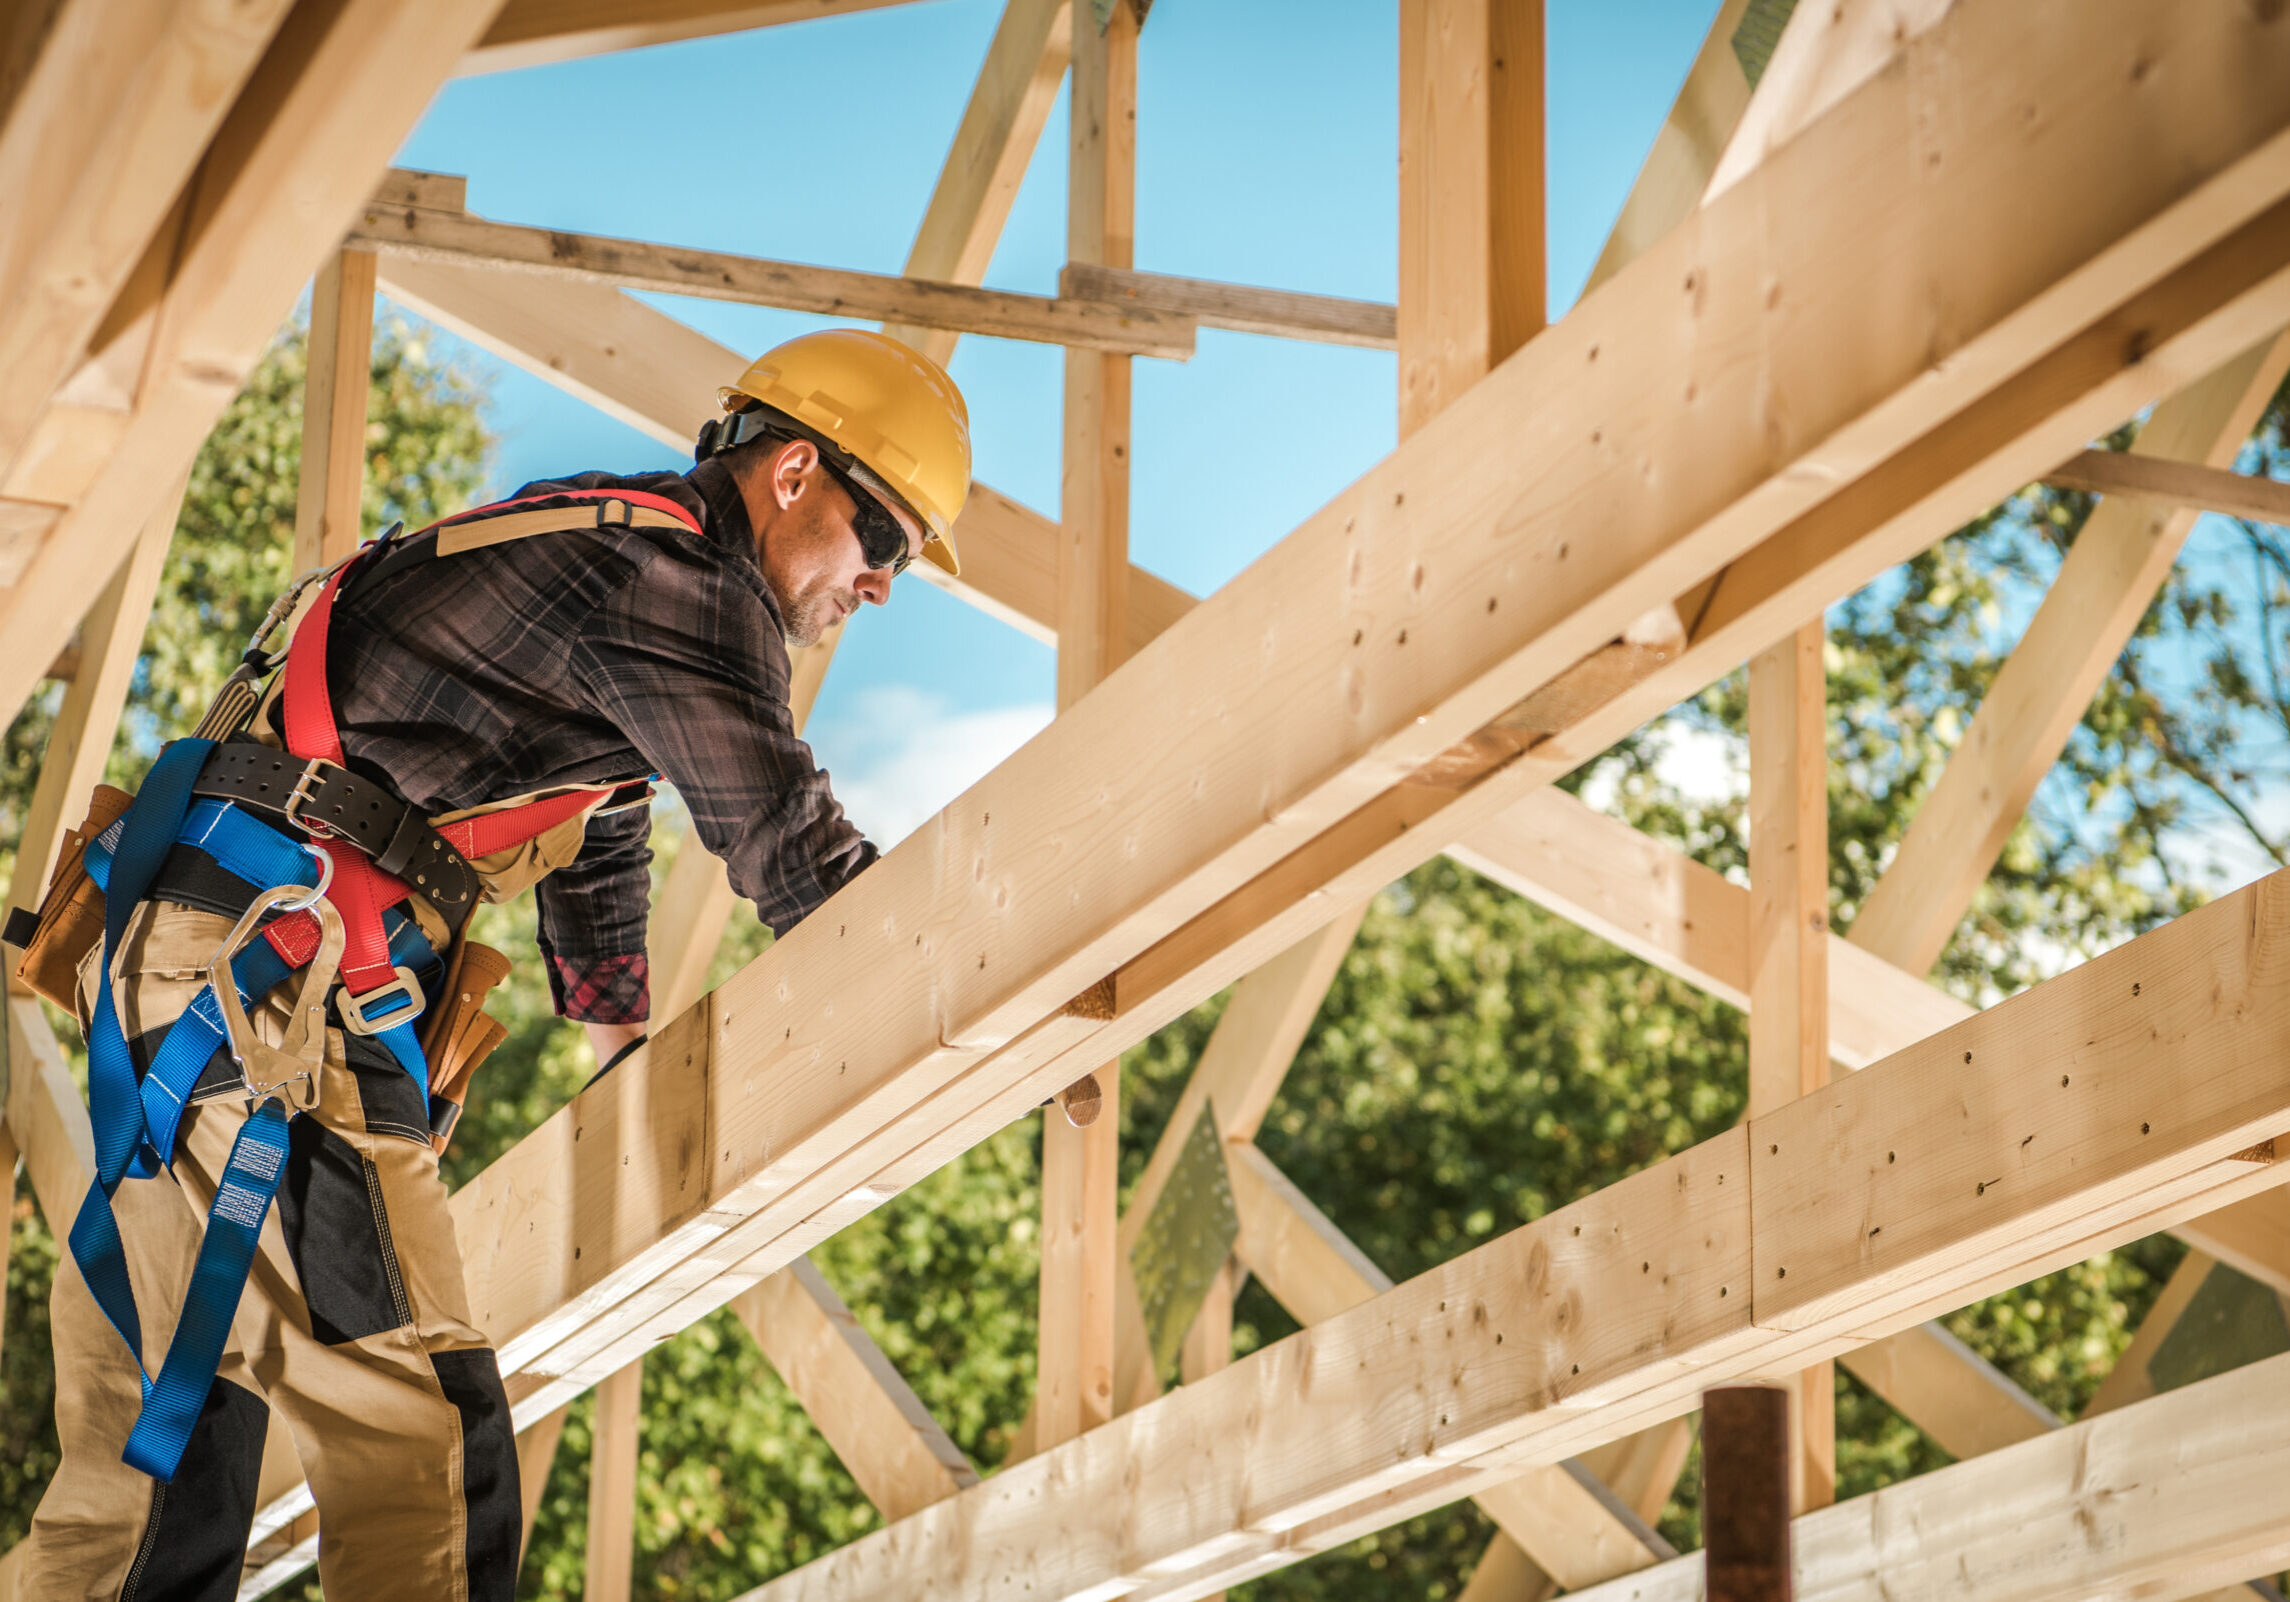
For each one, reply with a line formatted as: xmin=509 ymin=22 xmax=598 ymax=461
xmin=384 ymin=0 xmax=1715 ymax=838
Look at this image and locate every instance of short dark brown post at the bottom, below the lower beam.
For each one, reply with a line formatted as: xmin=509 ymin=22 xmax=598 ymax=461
xmin=1701 ymin=1385 xmax=1798 ymax=1602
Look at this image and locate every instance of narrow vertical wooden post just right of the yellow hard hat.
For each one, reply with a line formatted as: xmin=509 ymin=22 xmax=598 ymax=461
xmin=1035 ymin=0 xmax=1138 ymax=1449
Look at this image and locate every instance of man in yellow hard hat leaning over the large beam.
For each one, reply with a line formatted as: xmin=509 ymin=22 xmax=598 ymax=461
xmin=23 ymin=330 xmax=969 ymax=1602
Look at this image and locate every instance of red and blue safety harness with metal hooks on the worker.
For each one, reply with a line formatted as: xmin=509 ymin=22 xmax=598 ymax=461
xmin=71 ymin=490 xmax=703 ymax=1481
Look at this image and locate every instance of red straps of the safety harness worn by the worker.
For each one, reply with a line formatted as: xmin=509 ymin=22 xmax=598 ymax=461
xmin=268 ymin=490 xmax=701 ymax=996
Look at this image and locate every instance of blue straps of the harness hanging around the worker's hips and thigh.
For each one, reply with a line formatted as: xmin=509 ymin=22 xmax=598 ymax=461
xmin=71 ymin=739 xmax=435 ymax=1481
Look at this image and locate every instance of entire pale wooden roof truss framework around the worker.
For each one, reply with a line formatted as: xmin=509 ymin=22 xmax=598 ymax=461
xmin=0 ymin=0 xmax=2290 ymax=1602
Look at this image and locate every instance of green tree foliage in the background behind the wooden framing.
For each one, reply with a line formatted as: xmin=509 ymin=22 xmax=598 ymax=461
xmin=0 ymin=332 xmax=2290 ymax=1602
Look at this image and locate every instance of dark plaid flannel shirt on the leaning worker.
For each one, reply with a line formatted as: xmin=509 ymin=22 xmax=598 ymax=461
xmin=327 ymin=462 xmax=875 ymax=1023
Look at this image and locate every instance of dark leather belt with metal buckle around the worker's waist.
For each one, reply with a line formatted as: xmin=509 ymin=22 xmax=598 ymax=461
xmin=190 ymin=739 xmax=483 ymax=929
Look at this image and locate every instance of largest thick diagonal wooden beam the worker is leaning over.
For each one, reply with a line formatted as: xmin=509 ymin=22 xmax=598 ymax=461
xmin=246 ymin=0 xmax=2290 ymax=1556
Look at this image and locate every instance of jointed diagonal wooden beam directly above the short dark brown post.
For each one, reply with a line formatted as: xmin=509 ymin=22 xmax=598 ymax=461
xmin=756 ymin=874 xmax=2290 ymax=1602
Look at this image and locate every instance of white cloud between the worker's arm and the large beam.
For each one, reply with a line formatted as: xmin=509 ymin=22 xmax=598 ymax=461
xmin=813 ymin=684 xmax=1051 ymax=849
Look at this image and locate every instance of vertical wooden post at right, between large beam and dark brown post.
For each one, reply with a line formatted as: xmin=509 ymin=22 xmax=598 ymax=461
xmin=1750 ymin=622 xmax=1837 ymax=1513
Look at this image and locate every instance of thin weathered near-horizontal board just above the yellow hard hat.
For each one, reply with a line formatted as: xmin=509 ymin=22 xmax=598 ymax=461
xmin=346 ymin=206 xmax=1193 ymax=362
